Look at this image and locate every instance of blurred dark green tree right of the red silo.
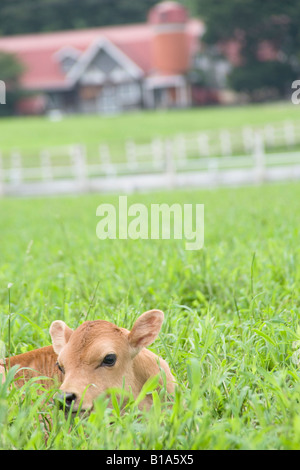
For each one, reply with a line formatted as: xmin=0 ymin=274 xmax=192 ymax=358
xmin=194 ymin=0 xmax=300 ymax=98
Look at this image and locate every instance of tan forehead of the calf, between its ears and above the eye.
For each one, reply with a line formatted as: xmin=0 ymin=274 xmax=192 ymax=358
xmin=66 ymin=320 xmax=128 ymax=361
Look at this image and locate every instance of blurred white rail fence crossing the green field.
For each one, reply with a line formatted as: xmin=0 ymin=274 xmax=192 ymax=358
xmin=0 ymin=122 xmax=300 ymax=195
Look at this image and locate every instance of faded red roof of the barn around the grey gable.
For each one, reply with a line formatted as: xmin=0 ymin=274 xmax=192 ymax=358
xmin=0 ymin=20 xmax=203 ymax=90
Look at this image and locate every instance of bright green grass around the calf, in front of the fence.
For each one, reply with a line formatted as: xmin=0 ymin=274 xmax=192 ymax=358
xmin=0 ymin=182 xmax=300 ymax=449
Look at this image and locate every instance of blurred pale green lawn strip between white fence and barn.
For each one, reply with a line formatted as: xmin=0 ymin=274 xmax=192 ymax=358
xmin=0 ymin=102 xmax=299 ymax=155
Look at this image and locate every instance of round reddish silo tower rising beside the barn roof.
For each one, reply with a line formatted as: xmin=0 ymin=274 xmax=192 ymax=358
xmin=148 ymin=2 xmax=189 ymax=75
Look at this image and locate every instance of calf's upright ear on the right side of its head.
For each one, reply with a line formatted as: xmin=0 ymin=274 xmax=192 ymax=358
xmin=128 ymin=310 xmax=164 ymax=355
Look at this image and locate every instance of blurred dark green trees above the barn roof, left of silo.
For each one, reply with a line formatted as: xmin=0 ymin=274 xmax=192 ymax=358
xmin=0 ymin=0 xmax=157 ymax=36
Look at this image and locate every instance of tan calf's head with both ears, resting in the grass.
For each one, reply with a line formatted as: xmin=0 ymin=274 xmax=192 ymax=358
xmin=50 ymin=310 xmax=164 ymax=411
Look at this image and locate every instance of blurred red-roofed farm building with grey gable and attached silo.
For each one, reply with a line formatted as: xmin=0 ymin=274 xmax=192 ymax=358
xmin=0 ymin=1 xmax=213 ymax=113
